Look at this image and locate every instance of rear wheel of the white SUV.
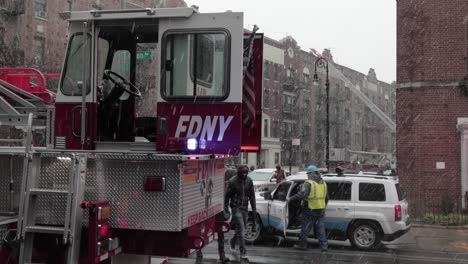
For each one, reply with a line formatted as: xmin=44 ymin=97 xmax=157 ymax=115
xmin=348 ymin=221 xmax=382 ymax=250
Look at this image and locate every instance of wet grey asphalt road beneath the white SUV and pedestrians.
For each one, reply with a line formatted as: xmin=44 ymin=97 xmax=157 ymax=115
xmin=169 ymin=227 xmax=468 ymax=264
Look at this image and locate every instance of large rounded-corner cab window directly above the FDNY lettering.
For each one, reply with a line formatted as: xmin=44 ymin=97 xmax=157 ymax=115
xmin=161 ymin=31 xmax=229 ymax=101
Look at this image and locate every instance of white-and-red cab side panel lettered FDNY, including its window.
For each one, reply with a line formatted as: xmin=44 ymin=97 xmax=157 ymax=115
xmin=156 ymin=12 xmax=243 ymax=154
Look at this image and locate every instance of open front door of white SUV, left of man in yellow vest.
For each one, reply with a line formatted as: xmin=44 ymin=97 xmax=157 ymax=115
xmin=268 ymin=181 xmax=292 ymax=233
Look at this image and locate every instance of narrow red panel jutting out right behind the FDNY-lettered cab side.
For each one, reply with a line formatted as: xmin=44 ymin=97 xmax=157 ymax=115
xmin=241 ymin=31 xmax=263 ymax=152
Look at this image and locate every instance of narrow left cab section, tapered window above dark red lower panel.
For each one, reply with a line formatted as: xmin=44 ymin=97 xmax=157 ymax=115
xmin=54 ymin=22 xmax=96 ymax=149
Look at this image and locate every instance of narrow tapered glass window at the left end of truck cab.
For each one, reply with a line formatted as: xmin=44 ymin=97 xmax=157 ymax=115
xmin=60 ymin=33 xmax=91 ymax=96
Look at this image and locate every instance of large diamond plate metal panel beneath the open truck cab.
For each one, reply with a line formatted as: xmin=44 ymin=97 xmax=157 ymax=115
xmin=85 ymin=155 xmax=181 ymax=231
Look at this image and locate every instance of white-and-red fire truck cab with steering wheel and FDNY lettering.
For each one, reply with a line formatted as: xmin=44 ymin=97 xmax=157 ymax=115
xmin=54 ymin=8 xmax=259 ymax=154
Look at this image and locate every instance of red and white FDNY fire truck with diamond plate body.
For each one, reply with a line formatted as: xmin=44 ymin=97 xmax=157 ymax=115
xmin=0 ymin=8 xmax=263 ymax=263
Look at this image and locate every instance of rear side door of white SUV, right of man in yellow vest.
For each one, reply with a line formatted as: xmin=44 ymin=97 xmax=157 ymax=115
xmin=325 ymin=178 xmax=355 ymax=236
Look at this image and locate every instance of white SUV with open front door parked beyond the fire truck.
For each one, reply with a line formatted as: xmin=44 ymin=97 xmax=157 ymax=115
xmin=245 ymin=173 xmax=411 ymax=250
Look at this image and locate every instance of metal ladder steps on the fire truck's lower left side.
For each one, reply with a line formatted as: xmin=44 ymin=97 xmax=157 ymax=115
xmin=17 ymin=152 xmax=87 ymax=264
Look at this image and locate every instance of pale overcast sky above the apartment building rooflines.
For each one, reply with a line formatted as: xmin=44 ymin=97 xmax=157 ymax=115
xmin=185 ymin=0 xmax=396 ymax=82
